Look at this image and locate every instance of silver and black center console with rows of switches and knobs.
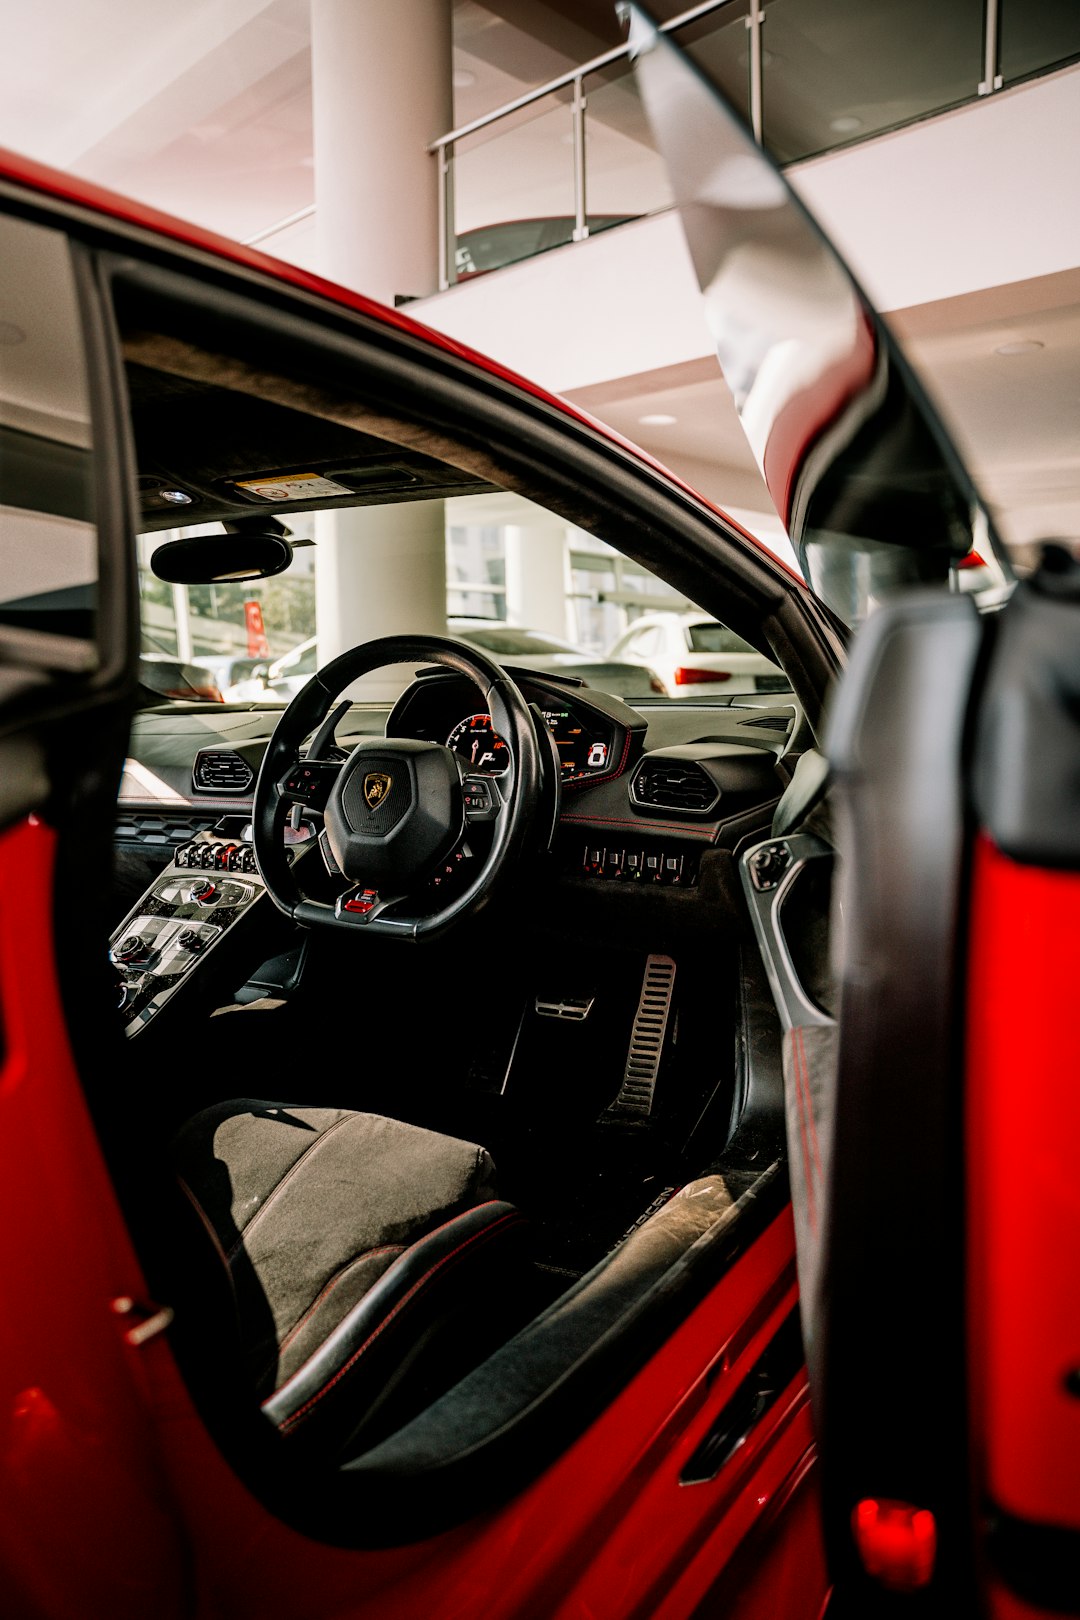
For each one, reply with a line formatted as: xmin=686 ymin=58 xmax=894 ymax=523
xmin=108 ymin=818 xmax=264 ymax=1035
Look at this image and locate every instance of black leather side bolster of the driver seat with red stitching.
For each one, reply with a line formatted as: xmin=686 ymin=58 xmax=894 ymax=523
xmin=262 ymin=1199 xmax=525 ymax=1434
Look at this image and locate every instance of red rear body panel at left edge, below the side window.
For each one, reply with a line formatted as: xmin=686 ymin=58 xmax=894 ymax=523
xmin=0 ymin=816 xmax=186 ymax=1620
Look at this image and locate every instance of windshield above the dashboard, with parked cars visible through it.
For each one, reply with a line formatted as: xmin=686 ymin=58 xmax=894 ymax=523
xmin=139 ymin=492 xmax=789 ymax=705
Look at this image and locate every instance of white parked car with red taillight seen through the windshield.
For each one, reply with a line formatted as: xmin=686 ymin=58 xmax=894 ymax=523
xmin=607 ymin=612 xmax=790 ymax=698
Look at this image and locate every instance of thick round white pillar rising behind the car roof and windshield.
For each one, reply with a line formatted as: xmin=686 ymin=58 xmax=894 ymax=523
xmin=311 ymin=0 xmax=453 ymax=673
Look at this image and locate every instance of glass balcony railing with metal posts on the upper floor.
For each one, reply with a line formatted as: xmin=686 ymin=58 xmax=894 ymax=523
xmin=432 ymin=0 xmax=1080 ymax=288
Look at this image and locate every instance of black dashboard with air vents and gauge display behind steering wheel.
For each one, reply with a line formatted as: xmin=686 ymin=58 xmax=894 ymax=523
xmin=117 ymin=669 xmax=798 ymax=946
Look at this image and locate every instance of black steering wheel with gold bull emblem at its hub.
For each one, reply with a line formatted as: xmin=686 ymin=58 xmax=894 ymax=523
xmin=251 ymin=635 xmax=544 ymax=940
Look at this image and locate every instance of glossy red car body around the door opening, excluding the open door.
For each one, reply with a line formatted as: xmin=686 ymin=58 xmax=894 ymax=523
xmin=0 ymin=145 xmax=826 ymax=1620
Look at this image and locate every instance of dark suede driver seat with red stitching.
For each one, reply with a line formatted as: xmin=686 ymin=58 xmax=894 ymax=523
xmin=173 ymin=1098 xmax=525 ymax=1461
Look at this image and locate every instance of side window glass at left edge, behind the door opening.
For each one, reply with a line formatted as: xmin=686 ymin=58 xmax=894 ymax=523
xmin=0 ymin=217 xmax=97 ymax=667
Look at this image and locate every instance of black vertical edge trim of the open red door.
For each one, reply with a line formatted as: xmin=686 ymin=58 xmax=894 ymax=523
xmin=819 ymin=591 xmax=983 ymax=1615
